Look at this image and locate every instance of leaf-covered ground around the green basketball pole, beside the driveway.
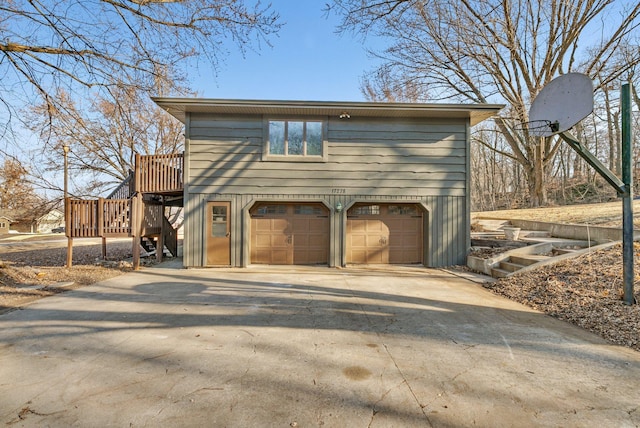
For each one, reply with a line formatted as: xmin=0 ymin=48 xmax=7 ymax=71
xmin=484 ymin=243 xmax=640 ymax=351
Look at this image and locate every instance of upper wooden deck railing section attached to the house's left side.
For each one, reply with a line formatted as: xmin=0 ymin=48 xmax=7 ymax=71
xmin=135 ymin=153 xmax=184 ymax=193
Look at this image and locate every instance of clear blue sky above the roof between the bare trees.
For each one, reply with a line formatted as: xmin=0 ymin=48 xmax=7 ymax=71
xmin=188 ymin=0 xmax=376 ymax=101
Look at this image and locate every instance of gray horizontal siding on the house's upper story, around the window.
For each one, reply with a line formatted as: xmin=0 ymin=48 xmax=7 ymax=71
xmin=188 ymin=115 xmax=467 ymax=197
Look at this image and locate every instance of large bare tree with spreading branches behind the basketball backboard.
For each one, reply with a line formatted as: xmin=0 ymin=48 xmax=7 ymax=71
xmin=329 ymin=0 xmax=640 ymax=206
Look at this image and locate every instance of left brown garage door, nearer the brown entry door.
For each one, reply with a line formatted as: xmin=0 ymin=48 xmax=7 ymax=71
xmin=250 ymin=203 xmax=329 ymax=265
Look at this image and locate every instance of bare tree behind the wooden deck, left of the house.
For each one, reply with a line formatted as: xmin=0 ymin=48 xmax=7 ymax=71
xmin=29 ymin=79 xmax=187 ymax=197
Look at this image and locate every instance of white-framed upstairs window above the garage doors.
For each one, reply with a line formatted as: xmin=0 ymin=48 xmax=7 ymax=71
xmin=265 ymin=120 xmax=326 ymax=162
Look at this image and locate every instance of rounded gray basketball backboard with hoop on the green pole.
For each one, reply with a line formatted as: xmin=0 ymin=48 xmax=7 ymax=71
xmin=528 ymin=73 xmax=593 ymax=137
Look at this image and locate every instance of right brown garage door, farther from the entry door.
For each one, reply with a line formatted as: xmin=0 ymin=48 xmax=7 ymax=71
xmin=347 ymin=204 xmax=423 ymax=264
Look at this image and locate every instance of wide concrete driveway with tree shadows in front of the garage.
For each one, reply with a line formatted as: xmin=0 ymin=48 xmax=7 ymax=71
xmin=0 ymin=265 xmax=640 ymax=427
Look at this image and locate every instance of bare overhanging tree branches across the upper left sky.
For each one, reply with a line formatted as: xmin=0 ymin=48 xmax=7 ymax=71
xmin=0 ymin=0 xmax=281 ymax=118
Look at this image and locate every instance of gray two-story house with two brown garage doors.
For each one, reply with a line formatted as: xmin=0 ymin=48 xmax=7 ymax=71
xmin=155 ymin=98 xmax=502 ymax=267
